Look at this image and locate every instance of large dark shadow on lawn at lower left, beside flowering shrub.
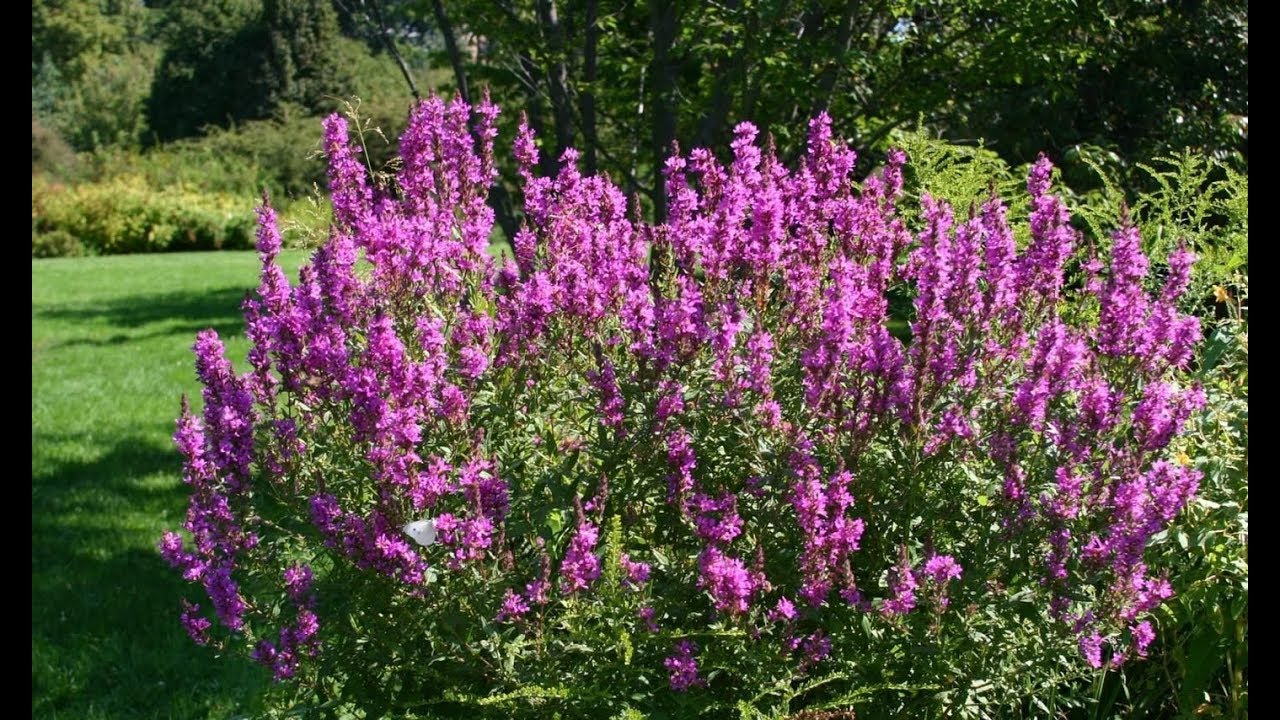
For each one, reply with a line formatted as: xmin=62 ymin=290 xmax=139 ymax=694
xmin=31 ymin=436 xmax=265 ymax=717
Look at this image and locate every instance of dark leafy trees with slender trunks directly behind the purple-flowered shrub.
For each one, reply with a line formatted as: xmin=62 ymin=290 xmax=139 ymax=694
xmin=404 ymin=0 xmax=1248 ymax=219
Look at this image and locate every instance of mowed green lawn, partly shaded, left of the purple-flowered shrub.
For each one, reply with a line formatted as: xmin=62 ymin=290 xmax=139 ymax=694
xmin=31 ymin=252 xmax=305 ymax=719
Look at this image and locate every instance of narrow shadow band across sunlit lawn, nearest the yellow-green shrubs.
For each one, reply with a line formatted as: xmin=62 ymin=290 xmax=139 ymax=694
xmin=33 ymin=286 xmax=248 ymax=347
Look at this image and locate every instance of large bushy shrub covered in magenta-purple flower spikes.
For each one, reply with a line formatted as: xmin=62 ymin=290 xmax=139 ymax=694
xmin=154 ymin=99 xmax=1203 ymax=716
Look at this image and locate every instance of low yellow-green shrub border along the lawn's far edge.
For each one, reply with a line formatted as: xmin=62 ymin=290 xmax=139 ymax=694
xmin=31 ymin=176 xmax=253 ymax=255
